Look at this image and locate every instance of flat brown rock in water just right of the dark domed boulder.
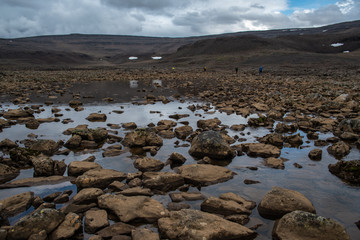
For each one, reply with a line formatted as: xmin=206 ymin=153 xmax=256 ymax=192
xmin=242 ymin=143 xmax=281 ymax=158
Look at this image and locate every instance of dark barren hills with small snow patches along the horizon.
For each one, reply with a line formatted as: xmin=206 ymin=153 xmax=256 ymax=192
xmin=0 ymin=21 xmax=360 ymax=68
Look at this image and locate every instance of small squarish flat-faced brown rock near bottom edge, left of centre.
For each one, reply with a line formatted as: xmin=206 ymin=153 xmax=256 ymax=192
xmin=85 ymin=210 xmax=109 ymax=233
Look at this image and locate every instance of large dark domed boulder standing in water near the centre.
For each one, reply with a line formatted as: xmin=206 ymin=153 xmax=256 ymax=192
xmin=189 ymin=131 xmax=236 ymax=160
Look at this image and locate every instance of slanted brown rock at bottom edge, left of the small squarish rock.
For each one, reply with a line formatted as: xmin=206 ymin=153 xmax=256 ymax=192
xmin=49 ymin=213 xmax=82 ymax=240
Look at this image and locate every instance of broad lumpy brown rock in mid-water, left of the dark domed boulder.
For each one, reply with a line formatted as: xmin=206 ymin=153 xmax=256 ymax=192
xmin=122 ymin=129 xmax=163 ymax=147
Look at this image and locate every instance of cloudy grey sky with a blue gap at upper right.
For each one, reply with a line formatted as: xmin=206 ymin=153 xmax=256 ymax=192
xmin=0 ymin=0 xmax=360 ymax=38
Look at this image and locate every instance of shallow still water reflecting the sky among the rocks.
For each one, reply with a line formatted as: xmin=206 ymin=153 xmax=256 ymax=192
xmin=0 ymin=98 xmax=360 ymax=239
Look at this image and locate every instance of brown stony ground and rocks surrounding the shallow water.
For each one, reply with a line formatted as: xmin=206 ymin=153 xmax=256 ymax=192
xmin=0 ymin=70 xmax=360 ymax=240
